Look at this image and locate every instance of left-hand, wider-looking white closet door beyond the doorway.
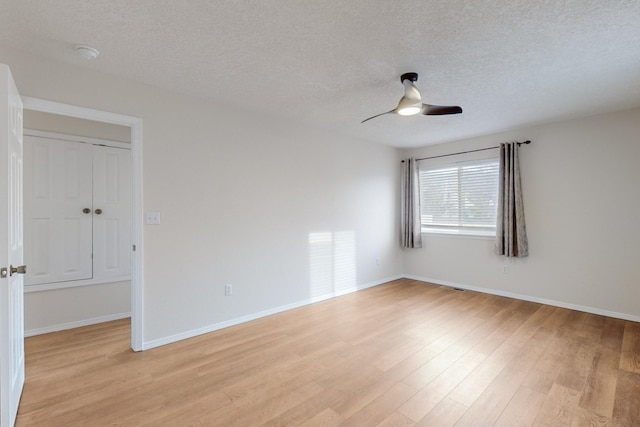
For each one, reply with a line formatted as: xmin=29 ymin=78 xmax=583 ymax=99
xmin=24 ymin=136 xmax=93 ymax=285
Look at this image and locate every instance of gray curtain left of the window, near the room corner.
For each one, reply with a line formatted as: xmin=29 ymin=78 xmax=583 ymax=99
xmin=400 ymin=158 xmax=422 ymax=248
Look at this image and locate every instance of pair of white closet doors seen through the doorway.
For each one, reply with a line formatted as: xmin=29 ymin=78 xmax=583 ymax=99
xmin=24 ymin=136 xmax=132 ymax=285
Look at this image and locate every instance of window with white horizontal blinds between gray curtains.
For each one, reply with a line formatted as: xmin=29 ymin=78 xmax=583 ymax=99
xmin=420 ymin=159 xmax=499 ymax=236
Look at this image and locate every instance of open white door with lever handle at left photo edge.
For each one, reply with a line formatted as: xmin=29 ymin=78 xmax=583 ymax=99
xmin=0 ymin=64 xmax=24 ymax=427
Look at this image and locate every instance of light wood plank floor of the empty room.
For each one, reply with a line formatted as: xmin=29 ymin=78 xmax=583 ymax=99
xmin=17 ymin=280 xmax=640 ymax=427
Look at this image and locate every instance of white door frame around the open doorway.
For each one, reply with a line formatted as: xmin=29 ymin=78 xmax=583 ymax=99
xmin=22 ymin=96 xmax=144 ymax=351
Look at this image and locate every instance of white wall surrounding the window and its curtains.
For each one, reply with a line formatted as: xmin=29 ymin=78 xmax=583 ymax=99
xmin=403 ymin=109 xmax=640 ymax=320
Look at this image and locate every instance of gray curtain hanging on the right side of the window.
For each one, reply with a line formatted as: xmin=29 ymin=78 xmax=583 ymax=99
xmin=495 ymin=142 xmax=529 ymax=258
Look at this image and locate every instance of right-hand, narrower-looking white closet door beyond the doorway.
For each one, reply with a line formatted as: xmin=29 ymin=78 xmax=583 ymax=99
xmin=93 ymin=146 xmax=133 ymax=278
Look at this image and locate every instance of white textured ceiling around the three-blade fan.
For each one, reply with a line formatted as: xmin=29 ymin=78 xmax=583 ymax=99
xmin=0 ymin=0 xmax=640 ymax=147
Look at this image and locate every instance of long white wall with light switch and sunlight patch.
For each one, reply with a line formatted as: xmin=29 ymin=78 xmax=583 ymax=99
xmin=0 ymin=47 xmax=402 ymax=347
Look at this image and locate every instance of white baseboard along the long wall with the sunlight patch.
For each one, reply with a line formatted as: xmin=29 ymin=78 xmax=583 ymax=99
xmin=142 ymin=275 xmax=403 ymax=350
